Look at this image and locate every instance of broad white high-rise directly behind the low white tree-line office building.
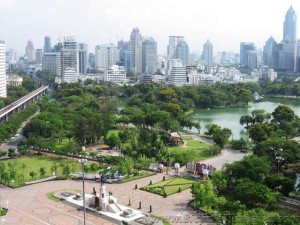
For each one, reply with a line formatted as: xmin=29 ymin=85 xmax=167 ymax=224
xmin=95 ymin=44 xmax=120 ymax=69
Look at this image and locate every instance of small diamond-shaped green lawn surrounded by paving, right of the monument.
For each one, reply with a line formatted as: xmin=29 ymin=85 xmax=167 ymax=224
xmin=141 ymin=177 xmax=197 ymax=196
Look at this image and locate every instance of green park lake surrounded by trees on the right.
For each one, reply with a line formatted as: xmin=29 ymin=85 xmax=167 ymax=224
xmin=189 ymin=98 xmax=300 ymax=139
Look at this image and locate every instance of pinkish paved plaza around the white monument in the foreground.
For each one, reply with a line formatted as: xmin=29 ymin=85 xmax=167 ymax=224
xmin=0 ymin=174 xmax=213 ymax=225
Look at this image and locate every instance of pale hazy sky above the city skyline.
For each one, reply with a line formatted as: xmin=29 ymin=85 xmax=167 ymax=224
xmin=0 ymin=0 xmax=300 ymax=56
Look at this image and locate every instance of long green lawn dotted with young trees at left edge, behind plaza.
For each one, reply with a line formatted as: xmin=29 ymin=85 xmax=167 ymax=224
xmin=2 ymin=155 xmax=85 ymax=187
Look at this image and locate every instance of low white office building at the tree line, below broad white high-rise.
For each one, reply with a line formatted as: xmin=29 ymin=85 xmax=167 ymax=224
xmin=104 ymin=65 xmax=126 ymax=84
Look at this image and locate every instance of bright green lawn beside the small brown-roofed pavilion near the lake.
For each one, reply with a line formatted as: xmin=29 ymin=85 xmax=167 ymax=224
xmin=168 ymin=136 xmax=211 ymax=160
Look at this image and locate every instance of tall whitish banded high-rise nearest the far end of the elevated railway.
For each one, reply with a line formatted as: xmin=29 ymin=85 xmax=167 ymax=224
xmin=56 ymin=36 xmax=79 ymax=83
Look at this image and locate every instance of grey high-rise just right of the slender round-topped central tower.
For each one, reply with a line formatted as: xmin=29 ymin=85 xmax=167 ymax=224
xmin=142 ymin=37 xmax=157 ymax=73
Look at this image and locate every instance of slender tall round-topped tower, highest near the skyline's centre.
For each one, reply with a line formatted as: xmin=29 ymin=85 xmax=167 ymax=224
xmin=130 ymin=27 xmax=142 ymax=74
